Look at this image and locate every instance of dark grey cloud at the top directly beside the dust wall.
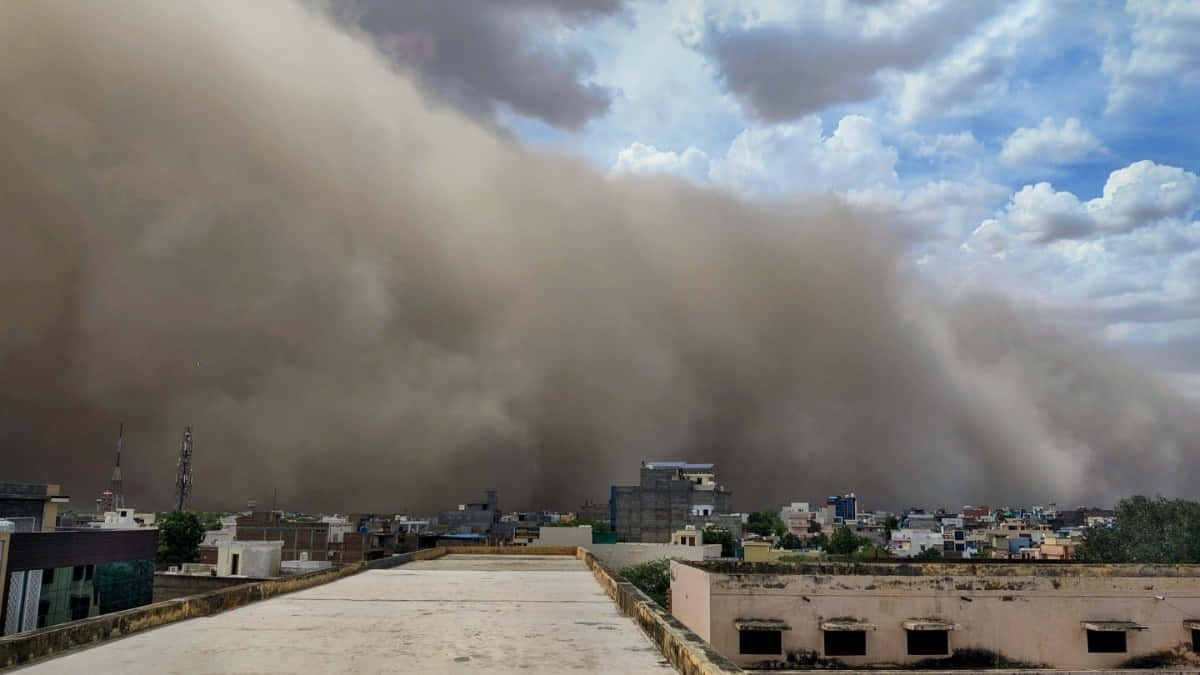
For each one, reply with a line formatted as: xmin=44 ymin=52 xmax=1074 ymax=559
xmin=331 ymin=0 xmax=623 ymax=129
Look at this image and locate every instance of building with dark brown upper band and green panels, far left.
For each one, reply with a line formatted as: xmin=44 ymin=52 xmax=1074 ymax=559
xmin=0 ymin=521 xmax=158 ymax=635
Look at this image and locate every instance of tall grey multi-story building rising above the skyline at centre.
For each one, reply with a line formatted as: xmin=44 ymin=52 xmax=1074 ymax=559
xmin=610 ymin=461 xmax=733 ymax=543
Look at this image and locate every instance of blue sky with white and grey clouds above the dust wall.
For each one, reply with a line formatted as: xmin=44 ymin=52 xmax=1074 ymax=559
xmin=362 ymin=0 xmax=1200 ymax=392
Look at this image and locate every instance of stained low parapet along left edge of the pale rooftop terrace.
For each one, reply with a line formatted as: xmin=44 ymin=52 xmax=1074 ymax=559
xmin=0 ymin=549 xmax=446 ymax=668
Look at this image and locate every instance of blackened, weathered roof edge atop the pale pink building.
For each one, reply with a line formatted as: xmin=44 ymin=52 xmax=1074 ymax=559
xmin=678 ymin=558 xmax=1200 ymax=578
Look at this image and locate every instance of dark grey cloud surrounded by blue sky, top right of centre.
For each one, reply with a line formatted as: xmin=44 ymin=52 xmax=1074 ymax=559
xmin=700 ymin=2 xmax=997 ymax=121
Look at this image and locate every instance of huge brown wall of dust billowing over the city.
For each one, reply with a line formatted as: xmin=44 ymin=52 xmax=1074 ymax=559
xmin=0 ymin=0 xmax=1200 ymax=512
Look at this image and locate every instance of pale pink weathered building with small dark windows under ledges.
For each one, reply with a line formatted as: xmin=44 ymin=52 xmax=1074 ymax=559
xmin=671 ymin=562 xmax=1200 ymax=669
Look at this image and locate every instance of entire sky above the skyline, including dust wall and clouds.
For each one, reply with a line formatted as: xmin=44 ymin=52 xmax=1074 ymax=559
xmin=0 ymin=0 xmax=1200 ymax=512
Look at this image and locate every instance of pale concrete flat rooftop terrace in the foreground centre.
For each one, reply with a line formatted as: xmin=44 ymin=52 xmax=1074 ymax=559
xmin=18 ymin=555 xmax=674 ymax=675
